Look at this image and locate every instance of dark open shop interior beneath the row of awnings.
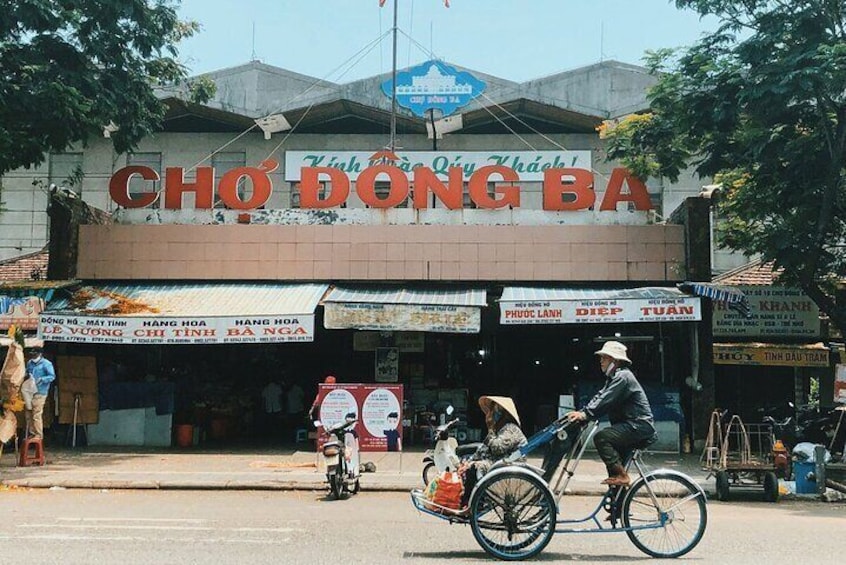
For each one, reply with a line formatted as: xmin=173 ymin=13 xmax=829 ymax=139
xmin=38 ymin=312 xmax=691 ymax=447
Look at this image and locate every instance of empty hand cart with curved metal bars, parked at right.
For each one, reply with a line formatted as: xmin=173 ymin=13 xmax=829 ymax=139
xmin=700 ymin=410 xmax=779 ymax=502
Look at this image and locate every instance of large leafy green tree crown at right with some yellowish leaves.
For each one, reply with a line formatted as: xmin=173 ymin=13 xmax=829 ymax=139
xmin=603 ymin=0 xmax=846 ymax=330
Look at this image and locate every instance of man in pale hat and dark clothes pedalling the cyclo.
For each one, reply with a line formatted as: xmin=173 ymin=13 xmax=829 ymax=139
xmin=567 ymin=341 xmax=658 ymax=486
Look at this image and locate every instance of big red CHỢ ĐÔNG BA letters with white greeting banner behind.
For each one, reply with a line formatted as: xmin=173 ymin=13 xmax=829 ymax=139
xmin=109 ymin=151 xmax=652 ymax=212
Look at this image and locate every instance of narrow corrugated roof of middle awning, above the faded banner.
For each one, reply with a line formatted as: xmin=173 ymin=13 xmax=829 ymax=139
xmin=323 ymin=287 xmax=488 ymax=307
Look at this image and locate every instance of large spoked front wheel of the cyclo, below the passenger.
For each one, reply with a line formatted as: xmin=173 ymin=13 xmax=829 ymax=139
xmin=470 ymin=471 xmax=557 ymax=561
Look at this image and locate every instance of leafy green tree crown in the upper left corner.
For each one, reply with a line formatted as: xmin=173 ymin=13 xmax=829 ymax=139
xmin=0 ymin=0 xmax=211 ymax=175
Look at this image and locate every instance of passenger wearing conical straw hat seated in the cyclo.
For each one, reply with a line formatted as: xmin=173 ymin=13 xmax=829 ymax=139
xmin=458 ymin=396 xmax=527 ymax=510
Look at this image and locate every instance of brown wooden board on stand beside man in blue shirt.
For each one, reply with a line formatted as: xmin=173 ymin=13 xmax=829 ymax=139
xmin=56 ymin=355 xmax=100 ymax=424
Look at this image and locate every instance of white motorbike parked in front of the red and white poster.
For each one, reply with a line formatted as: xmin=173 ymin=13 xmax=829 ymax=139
xmin=314 ymin=418 xmax=360 ymax=499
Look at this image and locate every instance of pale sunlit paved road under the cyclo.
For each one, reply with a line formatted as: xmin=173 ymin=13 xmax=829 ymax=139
xmin=0 ymin=489 xmax=846 ymax=565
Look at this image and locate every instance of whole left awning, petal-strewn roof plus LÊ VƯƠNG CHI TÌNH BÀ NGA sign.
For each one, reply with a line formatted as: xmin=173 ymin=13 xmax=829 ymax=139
xmin=38 ymin=283 xmax=328 ymax=344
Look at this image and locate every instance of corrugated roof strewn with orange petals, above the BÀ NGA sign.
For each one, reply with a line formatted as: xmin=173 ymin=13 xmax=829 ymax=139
xmin=44 ymin=283 xmax=329 ymax=317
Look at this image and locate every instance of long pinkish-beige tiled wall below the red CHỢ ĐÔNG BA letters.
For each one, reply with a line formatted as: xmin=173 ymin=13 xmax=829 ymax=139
xmin=77 ymin=225 xmax=685 ymax=282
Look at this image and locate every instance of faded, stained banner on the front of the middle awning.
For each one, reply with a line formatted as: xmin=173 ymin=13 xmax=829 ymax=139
xmin=323 ymin=302 xmax=482 ymax=333
